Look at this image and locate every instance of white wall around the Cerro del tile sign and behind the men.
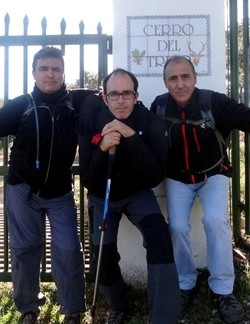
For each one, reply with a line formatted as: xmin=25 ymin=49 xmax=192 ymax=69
xmin=113 ymin=0 xmax=226 ymax=285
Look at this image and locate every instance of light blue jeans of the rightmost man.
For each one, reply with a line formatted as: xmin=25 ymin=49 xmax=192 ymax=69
xmin=166 ymin=175 xmax=235 ymax=294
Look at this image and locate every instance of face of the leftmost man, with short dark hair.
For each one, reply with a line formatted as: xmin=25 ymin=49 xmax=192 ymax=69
xmin=32 ymin=57 xmax=64 ymax=94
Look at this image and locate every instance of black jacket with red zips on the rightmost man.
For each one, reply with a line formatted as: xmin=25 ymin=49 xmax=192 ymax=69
xmin=150 ymin=88 xmax=250 ymax=183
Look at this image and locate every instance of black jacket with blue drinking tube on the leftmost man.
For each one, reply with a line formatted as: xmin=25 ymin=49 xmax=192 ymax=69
xmin=0 ymin=85 xmax=92 ymax=198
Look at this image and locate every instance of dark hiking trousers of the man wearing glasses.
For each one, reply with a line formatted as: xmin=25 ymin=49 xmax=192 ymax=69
xmin=89 ymin=189 xmax=180 ymax=324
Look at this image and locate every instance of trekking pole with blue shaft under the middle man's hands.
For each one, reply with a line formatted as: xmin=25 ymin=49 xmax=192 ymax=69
xmin=91 ymin=146 xmax=116 ymax=323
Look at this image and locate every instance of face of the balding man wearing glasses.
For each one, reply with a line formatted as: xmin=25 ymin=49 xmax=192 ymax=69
xmin=103 ymin=73 xmax=138 ymax=119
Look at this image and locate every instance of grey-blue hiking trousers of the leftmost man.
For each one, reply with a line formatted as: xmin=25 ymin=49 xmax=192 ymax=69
xmin=6 ymin=184 xmax=85 ymax=314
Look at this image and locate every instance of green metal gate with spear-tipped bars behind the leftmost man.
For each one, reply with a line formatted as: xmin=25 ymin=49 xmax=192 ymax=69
xmin=0 ymin=14 xmax=112 ymax=281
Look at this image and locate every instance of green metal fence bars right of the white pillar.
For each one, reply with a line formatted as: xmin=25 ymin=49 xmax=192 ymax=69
xmin=229 ymin=0 xmax=250 ymax=242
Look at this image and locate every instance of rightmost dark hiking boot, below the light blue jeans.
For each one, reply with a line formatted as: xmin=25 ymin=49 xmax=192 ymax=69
xmin=211 ymin=292 xmax=244 ymax=323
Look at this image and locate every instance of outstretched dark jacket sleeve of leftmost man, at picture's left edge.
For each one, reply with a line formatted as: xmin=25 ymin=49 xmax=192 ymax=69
xmin=0 ymin=95 xmax=29 ymax=137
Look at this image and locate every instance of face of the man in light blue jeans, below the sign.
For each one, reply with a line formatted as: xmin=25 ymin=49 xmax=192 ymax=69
xmin=164 ymin=60 xmax=196 ymax=106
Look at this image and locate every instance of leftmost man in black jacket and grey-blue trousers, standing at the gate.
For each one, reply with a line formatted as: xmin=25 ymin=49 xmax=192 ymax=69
xmin=0 ymin=47 xmax=94 ymax=324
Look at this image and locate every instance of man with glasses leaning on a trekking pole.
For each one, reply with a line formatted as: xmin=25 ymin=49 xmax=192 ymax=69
xmin=79 ymin=69 xmax=180 ymax=324
